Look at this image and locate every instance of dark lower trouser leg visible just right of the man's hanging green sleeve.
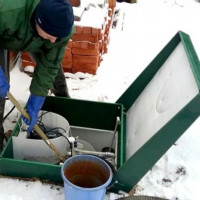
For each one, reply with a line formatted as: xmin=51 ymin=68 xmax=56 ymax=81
xmin=51 ymin=67 xmax=70 ymax=98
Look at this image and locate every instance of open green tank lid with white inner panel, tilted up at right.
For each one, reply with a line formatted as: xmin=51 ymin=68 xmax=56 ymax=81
xmin=112 ymin=31 xmax=200 ymax=192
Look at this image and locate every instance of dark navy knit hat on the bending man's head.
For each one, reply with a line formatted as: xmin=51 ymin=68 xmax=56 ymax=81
xmin=35 ymin=0 xmax=74 ymax=38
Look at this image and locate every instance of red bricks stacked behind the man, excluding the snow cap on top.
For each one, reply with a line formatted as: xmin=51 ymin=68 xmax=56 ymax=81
xmin=22 ymin=0 xmax=113 ymax=74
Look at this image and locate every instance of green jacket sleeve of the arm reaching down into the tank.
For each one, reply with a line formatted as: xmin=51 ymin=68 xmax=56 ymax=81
xmin=30 ymin=27 xmax=74 ymax=96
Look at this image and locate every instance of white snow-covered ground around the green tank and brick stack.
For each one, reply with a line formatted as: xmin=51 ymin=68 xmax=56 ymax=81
xmin=0 ymin=0 xmax=200 ymax=200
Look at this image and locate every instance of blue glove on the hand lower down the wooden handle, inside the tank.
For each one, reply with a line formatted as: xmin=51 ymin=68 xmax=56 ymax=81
xmin=22 ymin=94 xmax=45 ymax=133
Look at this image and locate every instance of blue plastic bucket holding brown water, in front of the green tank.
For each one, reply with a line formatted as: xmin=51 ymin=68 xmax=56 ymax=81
xmin=61 ymin=155 xmax=113 ymax=200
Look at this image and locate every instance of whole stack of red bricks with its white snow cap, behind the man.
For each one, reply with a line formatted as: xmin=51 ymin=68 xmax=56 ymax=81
xmin=22 ymin=0 xmax=114 ymax=75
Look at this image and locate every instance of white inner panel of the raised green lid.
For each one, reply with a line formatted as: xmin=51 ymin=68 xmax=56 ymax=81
xmin=126 ymin=43 xmax=199 ymax=159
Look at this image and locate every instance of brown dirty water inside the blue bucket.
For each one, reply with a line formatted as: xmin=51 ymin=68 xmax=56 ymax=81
xmin=64 ymin=161 xmax=109 ymax=188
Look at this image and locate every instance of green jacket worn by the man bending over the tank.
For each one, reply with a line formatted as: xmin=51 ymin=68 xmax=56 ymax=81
xmin=0 ymin=0 xmax=74 ymax=96
